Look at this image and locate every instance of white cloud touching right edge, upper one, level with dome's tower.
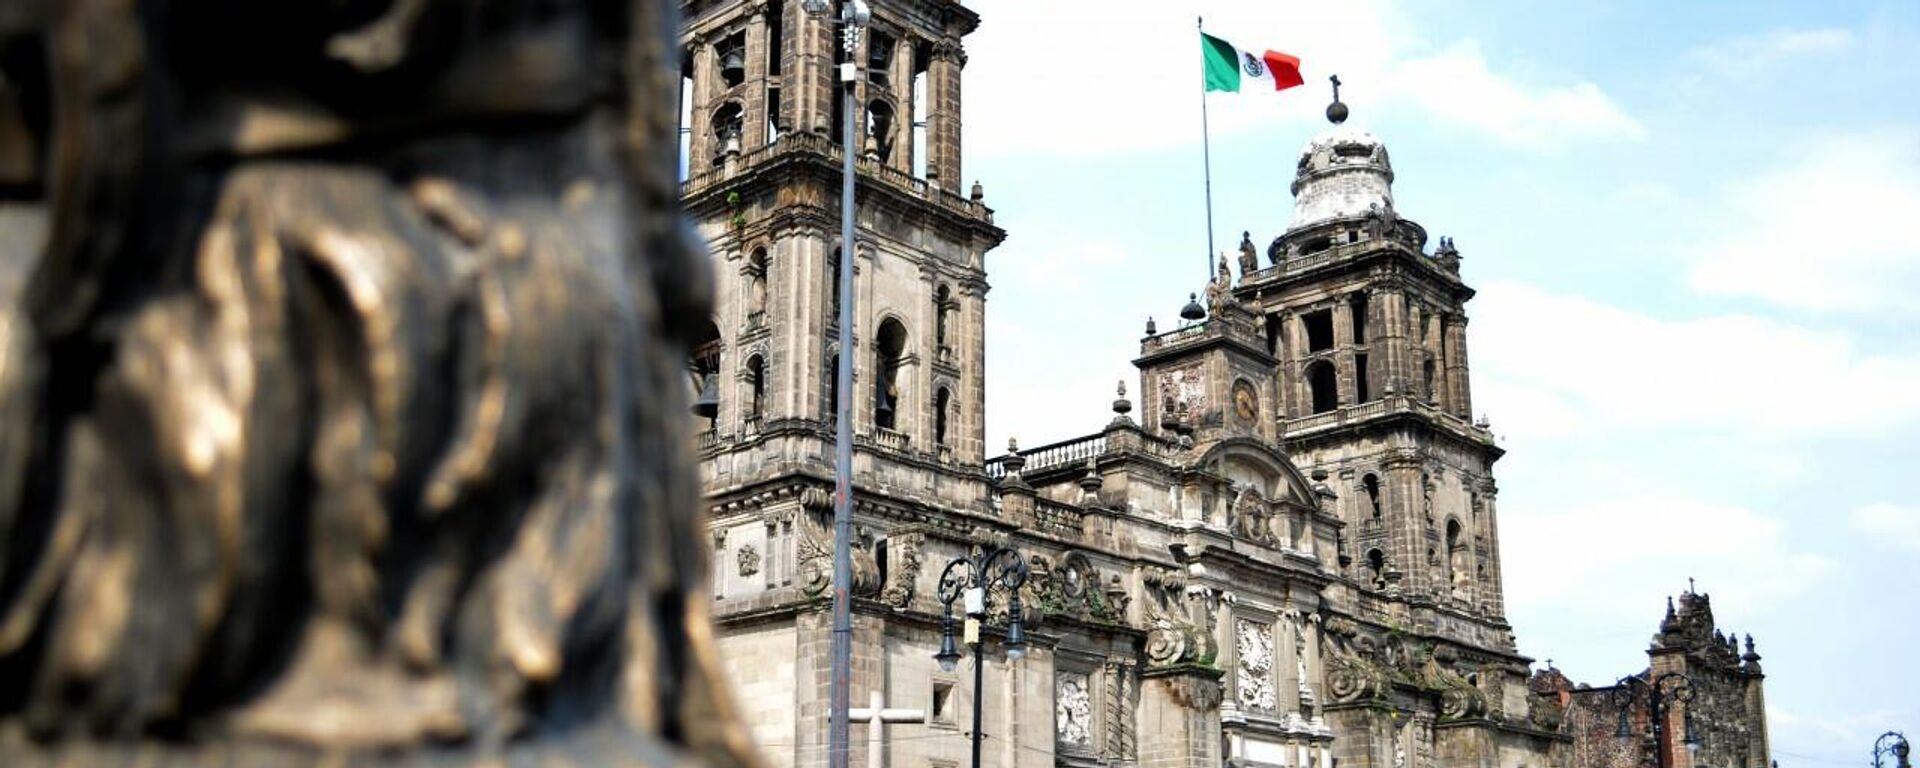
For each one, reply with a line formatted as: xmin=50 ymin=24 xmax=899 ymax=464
xmin=1686 ymin=131 xmax=1920 ymax=315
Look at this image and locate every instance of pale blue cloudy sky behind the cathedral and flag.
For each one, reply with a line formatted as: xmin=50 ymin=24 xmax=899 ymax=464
xmin=966 ymin=0 xmax=1920 ymax=766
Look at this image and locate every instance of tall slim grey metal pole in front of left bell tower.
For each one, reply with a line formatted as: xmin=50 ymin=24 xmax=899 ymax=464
xmin=801 ymin=0 xmax=872 ymax=768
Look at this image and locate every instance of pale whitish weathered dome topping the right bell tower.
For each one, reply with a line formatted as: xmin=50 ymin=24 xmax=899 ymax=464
xmin=1288 ymin=125 xmax=1394 ymax=230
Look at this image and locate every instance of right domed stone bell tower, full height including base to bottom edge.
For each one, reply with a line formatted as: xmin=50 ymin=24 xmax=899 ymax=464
xmin=1235 ymin=81 xmax=1551 ymax=766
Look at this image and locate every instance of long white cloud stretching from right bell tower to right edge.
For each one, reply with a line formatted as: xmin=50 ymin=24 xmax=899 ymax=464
xmin=1473 ymin=282 xmax=1920 ymax=437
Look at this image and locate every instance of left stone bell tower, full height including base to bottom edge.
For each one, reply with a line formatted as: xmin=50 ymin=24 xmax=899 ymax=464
xmin=680 ymin=0 xmax=1006 ymax=768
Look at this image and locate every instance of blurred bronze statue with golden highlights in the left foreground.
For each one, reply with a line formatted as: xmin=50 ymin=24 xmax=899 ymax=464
xmin=0 ymin=0 xmax=751 ymax=766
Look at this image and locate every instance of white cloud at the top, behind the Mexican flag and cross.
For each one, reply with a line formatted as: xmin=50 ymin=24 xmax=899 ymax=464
xmin=966 ymin=0 xmax=1644 ymax=154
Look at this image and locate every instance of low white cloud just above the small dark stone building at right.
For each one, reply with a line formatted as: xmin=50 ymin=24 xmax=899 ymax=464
xmin=1500 ymin=493 xmax=1834 ymax=632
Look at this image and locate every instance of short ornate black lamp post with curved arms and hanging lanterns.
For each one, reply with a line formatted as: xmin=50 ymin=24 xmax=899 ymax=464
xmin=933 ymin=547 xmax=1027 ymax=768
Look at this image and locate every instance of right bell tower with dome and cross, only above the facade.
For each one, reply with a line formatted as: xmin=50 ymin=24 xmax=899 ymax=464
xmin=1236 ymin=81 xmax=1511 ymax=643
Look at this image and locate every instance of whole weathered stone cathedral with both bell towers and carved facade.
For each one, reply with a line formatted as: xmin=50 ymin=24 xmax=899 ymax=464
xmin=682 ymin=0 xmax=1763 ymax=768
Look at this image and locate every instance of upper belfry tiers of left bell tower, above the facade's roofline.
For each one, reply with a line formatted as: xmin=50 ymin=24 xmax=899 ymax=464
xmin=682 ymin=0 xmax=1004 ymax=489
